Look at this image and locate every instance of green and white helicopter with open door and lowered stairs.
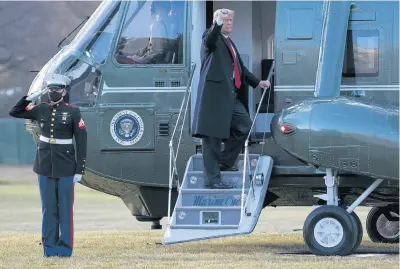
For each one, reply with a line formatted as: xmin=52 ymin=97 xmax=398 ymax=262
xmin=22 ymin=1 xmax=399 ymax=255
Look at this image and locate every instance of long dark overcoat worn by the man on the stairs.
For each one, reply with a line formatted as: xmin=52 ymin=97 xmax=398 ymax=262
xmin=192 ymin=22 xmax=260 ymax=140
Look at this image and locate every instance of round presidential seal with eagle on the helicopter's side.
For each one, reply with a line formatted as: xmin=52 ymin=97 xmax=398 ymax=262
xmin=110 ymin=110 xmax=144 ymax=146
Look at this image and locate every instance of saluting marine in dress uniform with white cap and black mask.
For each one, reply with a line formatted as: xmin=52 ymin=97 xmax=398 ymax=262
xmin=9 ymin=74 xmax=87 ymax=257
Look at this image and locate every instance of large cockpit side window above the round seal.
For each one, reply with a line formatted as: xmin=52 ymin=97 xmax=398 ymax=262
xmin=115 ymin=1 xmax=185 ymax=64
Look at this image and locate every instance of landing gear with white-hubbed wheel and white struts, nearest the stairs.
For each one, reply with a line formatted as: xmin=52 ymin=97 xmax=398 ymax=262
xmin=303 ymin=169 xmax=383 ymax=256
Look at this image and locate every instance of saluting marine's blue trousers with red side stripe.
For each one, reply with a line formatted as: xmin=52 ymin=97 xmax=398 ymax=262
xmin=39 ymin=176 xmax=74 ymax=256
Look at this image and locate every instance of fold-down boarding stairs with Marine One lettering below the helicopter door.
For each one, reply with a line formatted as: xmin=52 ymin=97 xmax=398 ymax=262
xmin=163 ymin=154 xmax=273 ymax=245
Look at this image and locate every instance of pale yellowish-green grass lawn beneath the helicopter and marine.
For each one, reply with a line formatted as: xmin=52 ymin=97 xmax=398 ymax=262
xmin=0 ymin=164 xmax=399 ymax=269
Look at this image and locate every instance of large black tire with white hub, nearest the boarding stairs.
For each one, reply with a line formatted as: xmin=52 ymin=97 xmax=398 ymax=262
xmin=303 ymin=205 xmax=362 ymax=256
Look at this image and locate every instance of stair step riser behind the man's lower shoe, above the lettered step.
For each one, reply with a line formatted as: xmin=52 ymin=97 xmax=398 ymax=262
xmin=184 ymin=170 xmax=251 ymax=189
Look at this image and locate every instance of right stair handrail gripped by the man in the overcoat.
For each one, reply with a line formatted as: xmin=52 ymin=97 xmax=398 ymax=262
xmin=239 ymin=60 xmax=275 ymax=226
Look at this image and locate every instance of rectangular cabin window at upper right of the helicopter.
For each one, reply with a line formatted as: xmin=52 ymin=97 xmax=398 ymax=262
xmin=342 ymin=30 xmax=379 ymax=77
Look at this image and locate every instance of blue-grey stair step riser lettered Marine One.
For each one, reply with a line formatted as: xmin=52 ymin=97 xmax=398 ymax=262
xmin=177 ymin=189 xmax=249 ymax=207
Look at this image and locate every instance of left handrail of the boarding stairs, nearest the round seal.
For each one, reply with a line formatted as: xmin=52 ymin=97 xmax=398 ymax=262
xmin=168 ymin=63 xmax=196 ymax=225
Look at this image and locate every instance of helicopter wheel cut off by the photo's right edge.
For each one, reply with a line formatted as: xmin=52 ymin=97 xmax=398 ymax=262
xmin=366 ymin=207 xmax=399 ymax=244
